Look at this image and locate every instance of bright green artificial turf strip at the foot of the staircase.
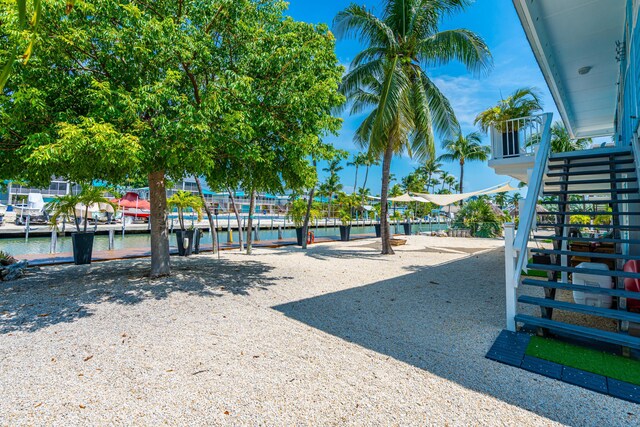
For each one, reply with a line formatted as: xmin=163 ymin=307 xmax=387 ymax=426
xmin=526 ymin=336 xmax=640 ymax=385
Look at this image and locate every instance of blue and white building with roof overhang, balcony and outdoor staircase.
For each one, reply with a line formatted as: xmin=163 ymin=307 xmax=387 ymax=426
xmin=489 ymin=0 xmax=640 ymax=356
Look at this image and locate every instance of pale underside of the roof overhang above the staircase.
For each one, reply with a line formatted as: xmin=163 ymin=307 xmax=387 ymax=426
xmin=513 ymin=0 xmax=627 ymax=138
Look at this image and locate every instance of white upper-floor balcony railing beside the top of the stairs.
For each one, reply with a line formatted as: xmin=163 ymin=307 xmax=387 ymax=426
xmin=491 ymin=114 xmax=548 ymax=160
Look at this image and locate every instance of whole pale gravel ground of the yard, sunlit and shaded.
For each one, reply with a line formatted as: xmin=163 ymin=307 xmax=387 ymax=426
xmin=0 ymin=236 xmax=640 ymax=426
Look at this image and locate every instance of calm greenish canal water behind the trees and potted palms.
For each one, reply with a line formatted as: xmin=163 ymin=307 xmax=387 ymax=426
xmin=0 ymin=224 xmax=446 ymax=255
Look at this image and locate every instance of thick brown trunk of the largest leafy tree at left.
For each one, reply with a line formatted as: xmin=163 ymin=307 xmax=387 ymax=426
xmin=149 ymin=171 xmax=171 ymax=277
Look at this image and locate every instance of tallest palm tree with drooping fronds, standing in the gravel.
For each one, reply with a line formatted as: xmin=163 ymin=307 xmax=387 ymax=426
xmin=334 ymin=0 xmax=492 ymax=254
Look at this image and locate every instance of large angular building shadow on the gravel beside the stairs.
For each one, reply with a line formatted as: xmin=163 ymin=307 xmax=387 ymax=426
xmin=273 ymin=249 xmax=638 ymax=425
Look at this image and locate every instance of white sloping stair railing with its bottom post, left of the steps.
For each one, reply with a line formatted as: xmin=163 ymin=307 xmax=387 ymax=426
xmin=505 ymin=113 xmax=553 ymax=331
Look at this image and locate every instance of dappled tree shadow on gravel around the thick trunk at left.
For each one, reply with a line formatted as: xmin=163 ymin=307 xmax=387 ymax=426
xmin=0 ymin=256 xmax=281 ymax=334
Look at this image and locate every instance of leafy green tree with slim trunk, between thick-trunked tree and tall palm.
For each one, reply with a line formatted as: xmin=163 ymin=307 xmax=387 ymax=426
xmin=204 ymin=13 xmax=344 ymax=252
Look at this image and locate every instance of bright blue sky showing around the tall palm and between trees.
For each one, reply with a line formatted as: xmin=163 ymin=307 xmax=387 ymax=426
xmin=288 ymin=0 xmax=559 ymax=194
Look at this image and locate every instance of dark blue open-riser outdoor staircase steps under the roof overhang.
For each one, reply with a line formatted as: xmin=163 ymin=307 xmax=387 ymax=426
xmin=514 ymin=148 xmax=640 ymax=350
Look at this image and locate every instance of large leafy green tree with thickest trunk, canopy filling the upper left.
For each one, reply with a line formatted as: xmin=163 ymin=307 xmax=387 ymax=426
xmin=0 ymin=0 xmax=341 ymax=276
